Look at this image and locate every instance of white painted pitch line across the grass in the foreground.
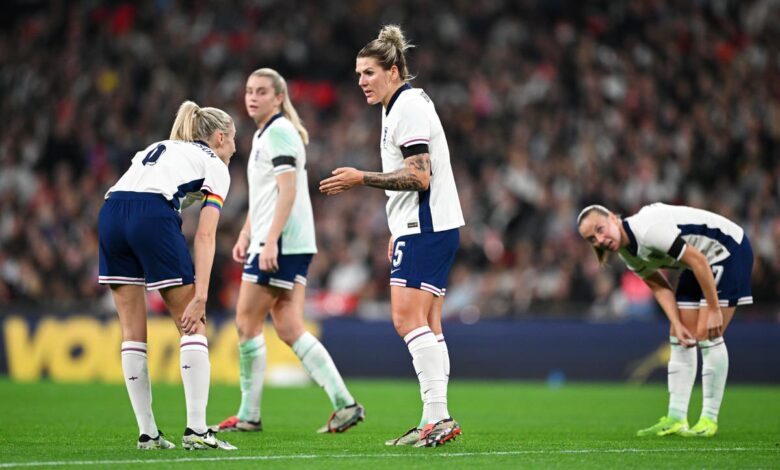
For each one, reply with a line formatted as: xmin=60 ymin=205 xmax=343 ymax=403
xmin=0 ymin=447 xmax=780 ymax=468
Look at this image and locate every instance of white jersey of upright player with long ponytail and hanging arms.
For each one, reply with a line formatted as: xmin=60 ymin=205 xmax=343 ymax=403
xmin=247 ymin=114 xmax=317 ymax=255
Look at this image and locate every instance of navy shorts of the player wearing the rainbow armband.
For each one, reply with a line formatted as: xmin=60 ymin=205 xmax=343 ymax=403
xmin=98 ymin=191 xmax=195 ymax=290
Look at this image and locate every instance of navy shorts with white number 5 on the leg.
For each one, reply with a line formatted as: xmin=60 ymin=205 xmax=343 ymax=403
xmin=390 ymin=228 xmax=460 ymax=297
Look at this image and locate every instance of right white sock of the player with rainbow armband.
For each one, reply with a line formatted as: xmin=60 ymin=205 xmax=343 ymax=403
xmin=179 ymin=335 xmax=211 ymax=434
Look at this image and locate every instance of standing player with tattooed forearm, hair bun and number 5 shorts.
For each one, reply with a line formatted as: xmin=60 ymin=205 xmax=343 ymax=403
xmin=320 ymin=25 xmax=464 ymax=447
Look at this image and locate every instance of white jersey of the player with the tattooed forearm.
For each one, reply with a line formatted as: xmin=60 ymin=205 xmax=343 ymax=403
xmin=379 ymin=84 xmax=465 ymax=238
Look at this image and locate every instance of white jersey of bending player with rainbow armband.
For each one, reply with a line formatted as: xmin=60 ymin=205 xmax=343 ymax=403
xmin=106 ymin=140 xmax=230 ymax=209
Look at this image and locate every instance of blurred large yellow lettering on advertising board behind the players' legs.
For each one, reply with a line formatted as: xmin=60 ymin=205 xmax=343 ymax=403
xmin=3 ymin=316 xmax=319 ymax=384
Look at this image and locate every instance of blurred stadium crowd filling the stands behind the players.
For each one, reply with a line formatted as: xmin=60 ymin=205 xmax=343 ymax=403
xmin=0 ymin=0 xmax=780 ymax=321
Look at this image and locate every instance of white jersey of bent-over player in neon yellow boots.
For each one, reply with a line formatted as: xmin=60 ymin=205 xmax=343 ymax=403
xmin=618 ymin=203 xmax=745 ymax=278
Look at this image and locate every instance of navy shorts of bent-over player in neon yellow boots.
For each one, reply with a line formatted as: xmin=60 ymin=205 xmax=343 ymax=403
xmin=676 ymin=234 xmax=753 ymax=309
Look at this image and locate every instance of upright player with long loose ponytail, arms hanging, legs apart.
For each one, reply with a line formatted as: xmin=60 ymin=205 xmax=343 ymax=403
xmin=212 ymin=68 xmax=365 ymax=432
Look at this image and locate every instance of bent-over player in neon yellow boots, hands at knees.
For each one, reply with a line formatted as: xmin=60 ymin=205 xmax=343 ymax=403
xmin=577 ymin=203 xmax=753 ymax=437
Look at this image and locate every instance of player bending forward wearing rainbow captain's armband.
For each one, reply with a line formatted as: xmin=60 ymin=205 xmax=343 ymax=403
xmin=98 ymin=101 xmax=236 ymax=450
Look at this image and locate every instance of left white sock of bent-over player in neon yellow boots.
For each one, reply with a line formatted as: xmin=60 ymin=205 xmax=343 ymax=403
xmin=667 ymin=336 xmax=699 ymax=419
